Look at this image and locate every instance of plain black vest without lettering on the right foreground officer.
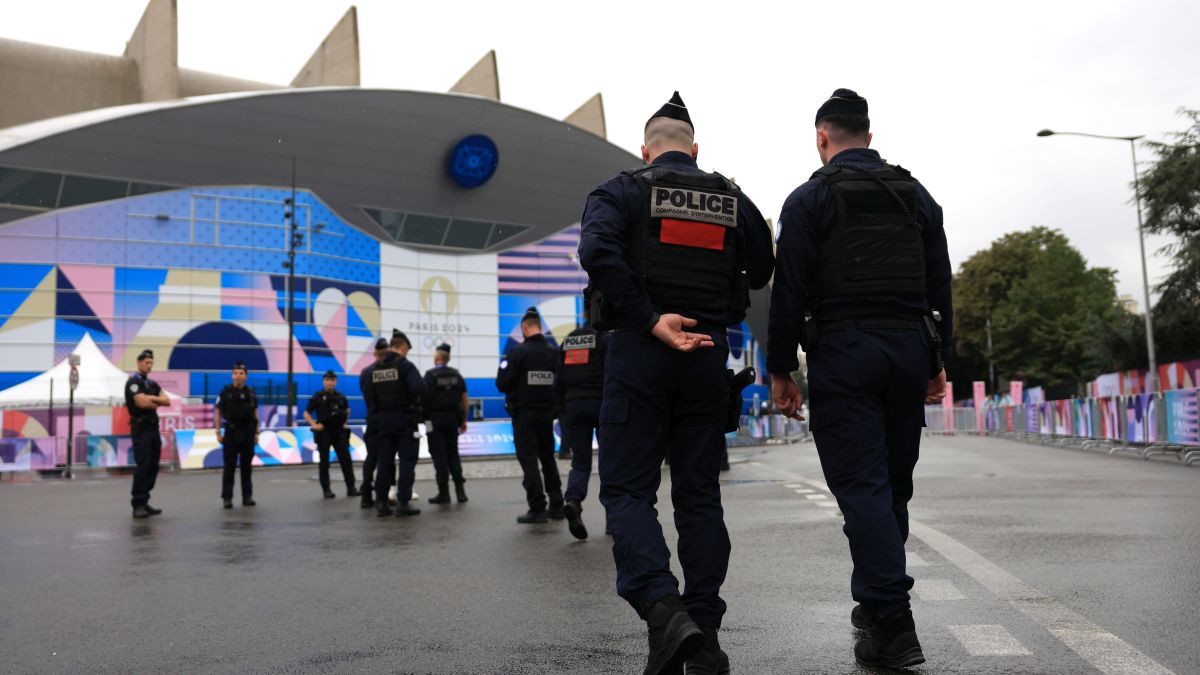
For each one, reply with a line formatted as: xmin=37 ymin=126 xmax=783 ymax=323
xmin=812 ymin=165 xmax=925 ymax=300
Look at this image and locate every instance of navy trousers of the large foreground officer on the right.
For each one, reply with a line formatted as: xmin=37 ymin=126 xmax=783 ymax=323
xmin=808 ymin=322 xmax=932 ymax=608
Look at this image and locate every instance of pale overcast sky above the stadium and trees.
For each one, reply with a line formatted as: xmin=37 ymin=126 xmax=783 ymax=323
xmin=0 ymin=0 xmax=1200 ymax=305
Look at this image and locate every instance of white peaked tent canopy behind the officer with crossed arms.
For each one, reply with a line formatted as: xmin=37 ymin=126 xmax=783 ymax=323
xmin=0 ymin=333 xmax=178 ymax=410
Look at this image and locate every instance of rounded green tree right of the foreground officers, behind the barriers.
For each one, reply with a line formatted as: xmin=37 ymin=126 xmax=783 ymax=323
xmin=952 ymin=227 xmax=1133 ymax=387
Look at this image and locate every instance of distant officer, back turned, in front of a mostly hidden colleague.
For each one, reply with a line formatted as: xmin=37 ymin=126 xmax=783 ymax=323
xmin=362 ymin=329 xmax=428 ymax=518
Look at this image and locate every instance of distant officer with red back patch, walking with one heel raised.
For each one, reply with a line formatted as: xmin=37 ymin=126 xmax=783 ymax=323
xmin=559 ymin=293 xmax=608 ymax=539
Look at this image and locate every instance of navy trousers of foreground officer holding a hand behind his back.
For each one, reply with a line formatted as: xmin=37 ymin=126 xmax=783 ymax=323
xmin=600 ymin=327 xmax=730 ymax=628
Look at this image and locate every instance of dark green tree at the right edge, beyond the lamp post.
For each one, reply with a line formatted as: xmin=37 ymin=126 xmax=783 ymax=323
xmin=1139 ymin=109 xmax=1200 ymax=363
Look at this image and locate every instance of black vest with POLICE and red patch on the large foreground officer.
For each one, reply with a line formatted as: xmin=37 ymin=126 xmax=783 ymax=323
xmin=626 ymin=167 xmax=750 ymax=323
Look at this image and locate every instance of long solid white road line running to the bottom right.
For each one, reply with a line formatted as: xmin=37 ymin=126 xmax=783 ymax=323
xmin=908 ymin=520 xmax=1171 ymax=675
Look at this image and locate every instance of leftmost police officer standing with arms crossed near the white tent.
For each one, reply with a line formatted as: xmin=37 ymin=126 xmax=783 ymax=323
xmin=125 ymin=350 xmax=170 ymax=518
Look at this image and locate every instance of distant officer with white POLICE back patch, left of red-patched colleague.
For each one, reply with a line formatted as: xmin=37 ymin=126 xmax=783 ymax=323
xmin=496 ymin=307 xmax=563 ymax=524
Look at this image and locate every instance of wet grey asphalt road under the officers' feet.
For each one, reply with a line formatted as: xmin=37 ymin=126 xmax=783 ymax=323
xmin=0 ymin=437 xmax=1200 ymax=674
